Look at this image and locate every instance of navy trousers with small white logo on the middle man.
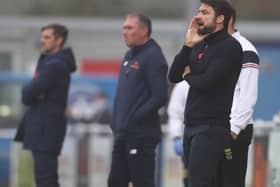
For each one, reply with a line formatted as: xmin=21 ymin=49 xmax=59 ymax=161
xmin=108 ymin=139 xmax=158 ymax=187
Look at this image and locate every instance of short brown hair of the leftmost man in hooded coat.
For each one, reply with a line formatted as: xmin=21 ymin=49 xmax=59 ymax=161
xmin=41 ymin=23 xmax=68 ymax=47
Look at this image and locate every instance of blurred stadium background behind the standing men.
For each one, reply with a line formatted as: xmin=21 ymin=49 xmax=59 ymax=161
xmin=0 ymin=0 xmax=280 ymax=187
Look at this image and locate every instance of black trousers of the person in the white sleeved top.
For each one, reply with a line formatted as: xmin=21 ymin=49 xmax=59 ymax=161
xmin=220 ymin=125 xmax=253 ymax=187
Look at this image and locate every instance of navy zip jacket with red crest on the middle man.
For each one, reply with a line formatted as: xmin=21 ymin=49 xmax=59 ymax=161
xmin=111 ymin=39 xmax=168 ymax=140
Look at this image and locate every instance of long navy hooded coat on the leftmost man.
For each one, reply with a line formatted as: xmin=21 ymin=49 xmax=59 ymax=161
xmin=16 ymin=48 xmax=76 ymax=153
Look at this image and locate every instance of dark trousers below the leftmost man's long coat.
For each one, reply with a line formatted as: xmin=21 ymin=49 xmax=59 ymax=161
xmin=32 ymin=151 xmax=59 ymax=187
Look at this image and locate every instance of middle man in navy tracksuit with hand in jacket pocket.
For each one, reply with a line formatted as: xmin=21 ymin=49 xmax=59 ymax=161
xmin=108 ymin=14 xmax=168 ymax=187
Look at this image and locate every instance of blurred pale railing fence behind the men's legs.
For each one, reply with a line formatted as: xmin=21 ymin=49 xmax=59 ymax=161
xmin=0 ymin=121 xmax=280 ymax=187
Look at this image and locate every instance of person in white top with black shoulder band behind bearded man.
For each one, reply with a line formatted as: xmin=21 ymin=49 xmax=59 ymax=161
xmin=221 ymin=5 xmax=259 ymax=187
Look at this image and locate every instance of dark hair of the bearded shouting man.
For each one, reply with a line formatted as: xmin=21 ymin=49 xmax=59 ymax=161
xmin=200 ymin=0 xmax=233 ymax=28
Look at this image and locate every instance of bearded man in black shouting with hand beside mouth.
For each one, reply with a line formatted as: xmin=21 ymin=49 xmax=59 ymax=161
xmin=169 ymin=0 xmax=242 ymax=187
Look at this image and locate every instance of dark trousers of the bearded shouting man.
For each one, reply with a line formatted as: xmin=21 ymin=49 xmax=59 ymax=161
xmin=183 ymin=125 xmax=230 ymax=187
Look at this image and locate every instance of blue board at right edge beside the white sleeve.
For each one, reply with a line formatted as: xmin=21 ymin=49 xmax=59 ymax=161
xmin=254 ymin=43 xmax=280 ymax=120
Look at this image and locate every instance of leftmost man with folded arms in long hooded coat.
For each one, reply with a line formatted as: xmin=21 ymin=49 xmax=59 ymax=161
xmin=15 ymin=24 xmax=76 ymax=187
